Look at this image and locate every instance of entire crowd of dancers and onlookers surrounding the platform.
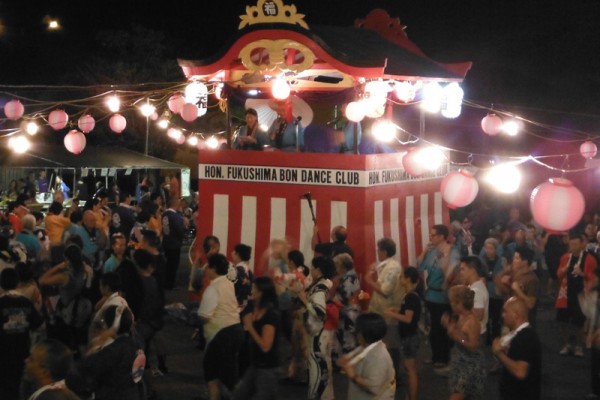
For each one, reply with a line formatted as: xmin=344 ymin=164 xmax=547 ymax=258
xmin=0 ymin=166 xmax=600 ymax=400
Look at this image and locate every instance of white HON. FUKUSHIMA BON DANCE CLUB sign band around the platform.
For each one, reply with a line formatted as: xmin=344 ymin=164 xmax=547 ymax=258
xmin=198 ymin=164 xmax=406 ymax=188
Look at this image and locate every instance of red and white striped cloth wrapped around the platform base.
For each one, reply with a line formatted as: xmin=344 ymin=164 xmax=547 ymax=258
xmin=198 ymin=151 xmax=448 ymax=274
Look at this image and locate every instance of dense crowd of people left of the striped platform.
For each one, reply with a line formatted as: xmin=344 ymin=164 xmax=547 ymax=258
xmin=0 ymin=173 xmax=193 ymax=399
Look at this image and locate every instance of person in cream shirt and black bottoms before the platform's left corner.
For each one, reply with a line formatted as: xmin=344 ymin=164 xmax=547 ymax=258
xmin=198 ymin=254 xmax=243 ymax=400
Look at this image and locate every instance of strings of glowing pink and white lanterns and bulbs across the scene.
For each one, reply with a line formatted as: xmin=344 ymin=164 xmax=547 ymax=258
xmin=0 ymin=78 xmax=597 ymax=231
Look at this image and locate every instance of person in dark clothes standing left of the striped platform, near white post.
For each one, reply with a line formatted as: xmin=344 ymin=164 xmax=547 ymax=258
xmin=162 ymin=197 xmax=185 ymax=289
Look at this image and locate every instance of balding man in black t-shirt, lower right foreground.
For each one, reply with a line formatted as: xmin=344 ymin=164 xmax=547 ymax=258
xmin=492 ymin=297 xmax=542 ymax=400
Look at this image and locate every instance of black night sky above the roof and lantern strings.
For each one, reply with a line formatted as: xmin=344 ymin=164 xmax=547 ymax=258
xmin=0 ymin=0 xmax=600 ymax=159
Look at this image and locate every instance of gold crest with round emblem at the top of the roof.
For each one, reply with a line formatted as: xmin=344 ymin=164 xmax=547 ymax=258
xmin=238 ymin=0 xmax=308 ymax=29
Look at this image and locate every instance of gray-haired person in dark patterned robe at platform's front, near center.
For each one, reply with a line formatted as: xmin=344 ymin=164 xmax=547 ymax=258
xmin=333 ymin=253 xmax=360 ymax=354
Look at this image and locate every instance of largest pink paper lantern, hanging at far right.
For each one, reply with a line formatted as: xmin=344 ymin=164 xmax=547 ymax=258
xmin=529 ymin=178 xmax=585 ymax=233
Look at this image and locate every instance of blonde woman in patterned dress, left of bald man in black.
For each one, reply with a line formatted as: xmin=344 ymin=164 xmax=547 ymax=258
xmin=442 ymin=285 xmax=487 ymax=400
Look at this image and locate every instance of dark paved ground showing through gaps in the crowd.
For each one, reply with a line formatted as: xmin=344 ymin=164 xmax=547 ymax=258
xmin=152 ymin=248 xmax=590 ymax=400
